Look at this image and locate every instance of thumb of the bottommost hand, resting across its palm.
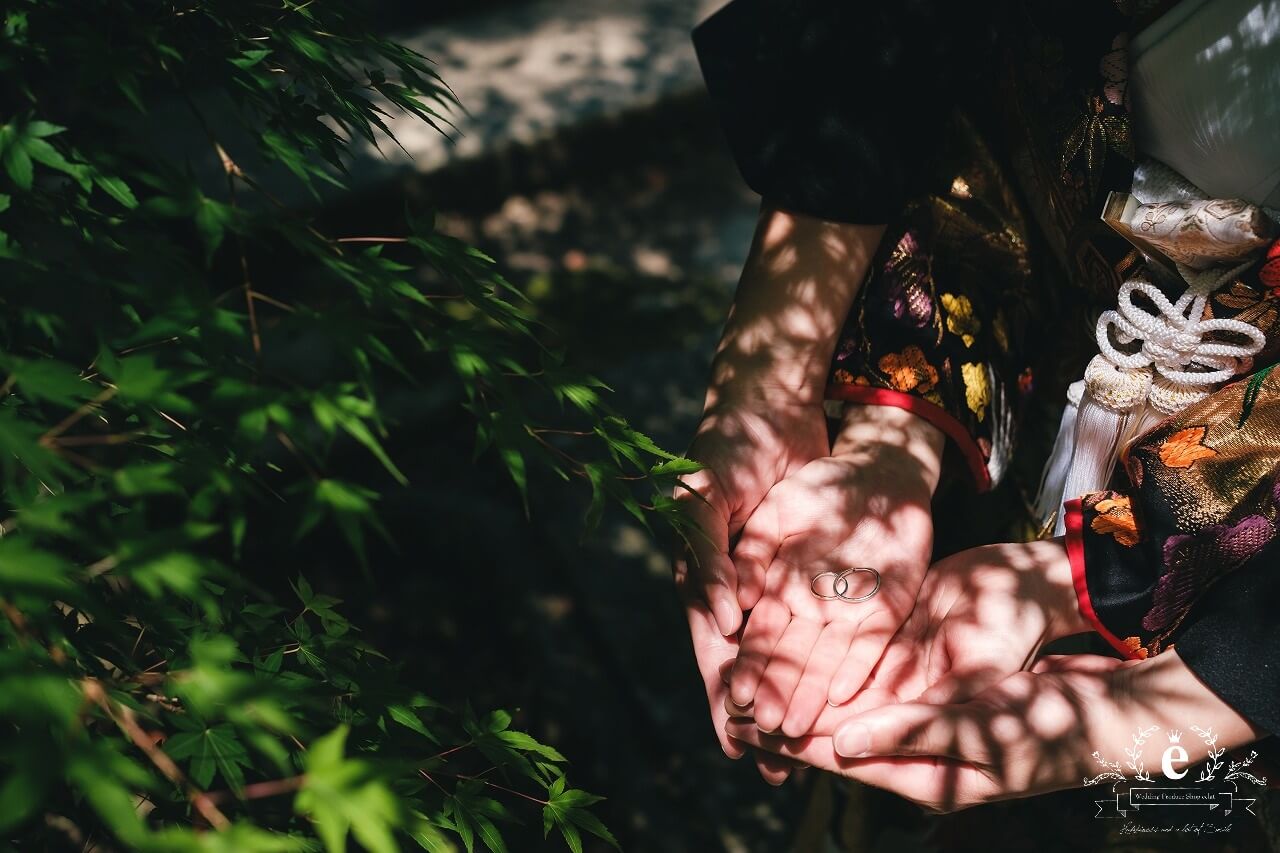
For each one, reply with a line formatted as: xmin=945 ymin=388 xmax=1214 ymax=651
xmin=832 ymin=702 xmax=967 ymax=762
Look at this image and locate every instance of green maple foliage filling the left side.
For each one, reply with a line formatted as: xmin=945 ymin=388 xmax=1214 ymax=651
xmin=0 ymin=0 xmax=691 ymax=853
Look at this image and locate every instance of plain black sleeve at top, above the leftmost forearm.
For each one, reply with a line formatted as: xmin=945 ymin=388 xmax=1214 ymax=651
xmin=694 ymin=0 xmax=998 ymax=223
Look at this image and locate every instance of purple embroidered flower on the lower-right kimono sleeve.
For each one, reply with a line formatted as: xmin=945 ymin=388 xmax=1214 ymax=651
xmin=1142 ymin=515 xmax=1276 ymax=631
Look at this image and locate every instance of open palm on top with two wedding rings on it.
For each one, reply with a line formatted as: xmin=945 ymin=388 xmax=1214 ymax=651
xmin=730 ymin=406 xmax=943 ymax=735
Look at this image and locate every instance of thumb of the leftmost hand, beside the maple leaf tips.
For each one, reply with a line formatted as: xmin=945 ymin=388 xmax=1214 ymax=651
xmin=676 ymin=474 xmax=742 ymax=637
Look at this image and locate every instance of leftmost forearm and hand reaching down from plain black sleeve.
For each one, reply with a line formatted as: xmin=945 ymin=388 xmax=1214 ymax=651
xmin=676 ymin=206 xmax=883 ymax=757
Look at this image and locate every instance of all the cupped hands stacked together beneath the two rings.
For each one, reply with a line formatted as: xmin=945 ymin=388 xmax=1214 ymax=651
xmin=677 ymin=394 xmax=1258 ymax=811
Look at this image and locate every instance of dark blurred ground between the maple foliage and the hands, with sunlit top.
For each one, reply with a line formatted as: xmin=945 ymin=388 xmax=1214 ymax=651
xmin=308 ymin=0 xmax=806 ymax=852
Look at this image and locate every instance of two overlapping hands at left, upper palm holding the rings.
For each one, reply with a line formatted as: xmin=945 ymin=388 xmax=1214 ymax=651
xmin=676 ymin=400 xmax=942 ymax=784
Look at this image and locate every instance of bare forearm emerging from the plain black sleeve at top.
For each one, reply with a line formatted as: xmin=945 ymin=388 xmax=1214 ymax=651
xmin=707 ymin=206 xmax=884 ymax=410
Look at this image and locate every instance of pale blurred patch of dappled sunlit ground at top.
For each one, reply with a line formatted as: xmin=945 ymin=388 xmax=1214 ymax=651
xmin=350 ymin=0 xmax=716 ymax=174
